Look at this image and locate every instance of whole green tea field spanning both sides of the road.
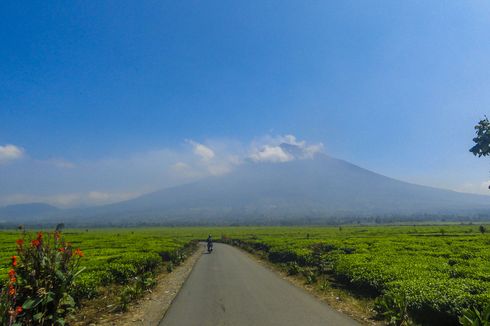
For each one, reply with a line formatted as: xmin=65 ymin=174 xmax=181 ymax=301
xmin=0 ymin=225 xmax=490 ymax=324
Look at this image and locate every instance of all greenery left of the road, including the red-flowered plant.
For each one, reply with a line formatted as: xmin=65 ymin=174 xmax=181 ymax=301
xmin=0 ymin=229 xmax=196 ymax=325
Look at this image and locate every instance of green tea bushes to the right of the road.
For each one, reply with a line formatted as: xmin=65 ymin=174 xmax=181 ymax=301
xmin=223 ymin=225 xmax=490 ymax=325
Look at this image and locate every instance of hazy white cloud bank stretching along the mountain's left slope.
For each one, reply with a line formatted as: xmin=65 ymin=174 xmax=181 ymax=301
xmin=0 ymin=135 xmax=322 ymax=207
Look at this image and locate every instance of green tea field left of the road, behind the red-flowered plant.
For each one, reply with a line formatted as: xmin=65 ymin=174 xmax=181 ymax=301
xmin=0 ymin=228 xmax=203 ymax=306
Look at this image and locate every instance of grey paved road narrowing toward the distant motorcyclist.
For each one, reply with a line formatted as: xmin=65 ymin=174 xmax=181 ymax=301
xmin=160 ymin=244 xmax=357 ymax=326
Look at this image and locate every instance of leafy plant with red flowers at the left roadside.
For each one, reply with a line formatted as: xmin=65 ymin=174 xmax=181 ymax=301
xmin=0 ymin=230 xmax=83 ymax=326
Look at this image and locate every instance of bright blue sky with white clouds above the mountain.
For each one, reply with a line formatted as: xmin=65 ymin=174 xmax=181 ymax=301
xmin=0 ymin=0 xmax=490 ymax=207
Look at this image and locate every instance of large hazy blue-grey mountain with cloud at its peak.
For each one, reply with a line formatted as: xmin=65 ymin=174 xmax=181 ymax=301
xmin=66 ymin=152 xmax=490 ymax=224
